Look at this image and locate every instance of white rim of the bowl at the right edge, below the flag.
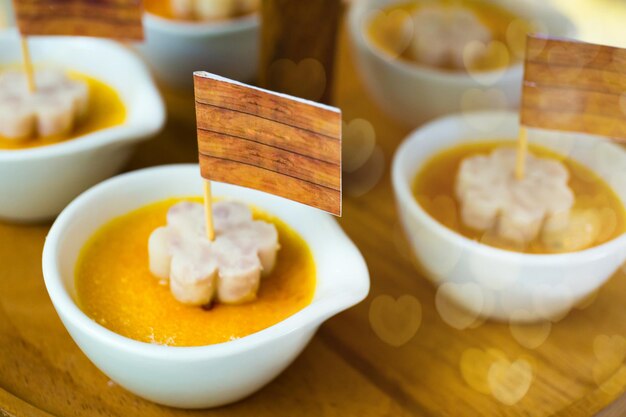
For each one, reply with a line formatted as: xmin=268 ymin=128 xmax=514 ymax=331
xmin=392 ymin=111 xmax=626 ymax=265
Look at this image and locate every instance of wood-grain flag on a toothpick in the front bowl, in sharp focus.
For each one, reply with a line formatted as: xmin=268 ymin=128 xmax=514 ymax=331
xmin=194 ymin=72 xmax=341 ymax=216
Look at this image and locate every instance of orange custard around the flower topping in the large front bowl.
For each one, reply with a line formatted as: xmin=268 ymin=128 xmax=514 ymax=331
xmin=76 ymin=198 xmax=315 ymax=346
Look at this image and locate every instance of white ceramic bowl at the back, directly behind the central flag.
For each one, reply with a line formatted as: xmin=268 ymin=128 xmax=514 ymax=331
xmin=136 ymin=13 xmax=260 ymax=91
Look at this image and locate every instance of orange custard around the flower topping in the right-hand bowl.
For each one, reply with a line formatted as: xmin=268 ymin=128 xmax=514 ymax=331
xmin=413 ymin=141 xmax=626 ymax=254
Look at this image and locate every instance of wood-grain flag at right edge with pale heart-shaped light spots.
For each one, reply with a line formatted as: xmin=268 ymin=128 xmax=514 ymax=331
xmin=521 ymin=36 xmax=626 ymax=142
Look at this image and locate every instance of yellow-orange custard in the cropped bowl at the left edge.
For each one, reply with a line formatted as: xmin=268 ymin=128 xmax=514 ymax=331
xmin=0 ymin=71 xmax=126 ymax=150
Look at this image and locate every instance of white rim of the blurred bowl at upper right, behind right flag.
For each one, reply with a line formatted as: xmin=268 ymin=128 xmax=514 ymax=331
xmin=349 ymin=0 xmax=577 ymax=85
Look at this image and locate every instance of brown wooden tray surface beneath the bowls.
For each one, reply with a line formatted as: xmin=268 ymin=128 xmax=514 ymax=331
xmin=0 ymin=22 xmax=626 ymax=417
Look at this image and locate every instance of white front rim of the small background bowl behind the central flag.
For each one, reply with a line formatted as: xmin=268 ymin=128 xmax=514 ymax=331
xmin=144 ymin=11 xmax=261 ymax=37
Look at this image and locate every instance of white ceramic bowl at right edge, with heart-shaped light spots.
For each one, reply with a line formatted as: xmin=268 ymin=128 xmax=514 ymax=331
xmin=392 ymin=112 xmax=626 ymax=321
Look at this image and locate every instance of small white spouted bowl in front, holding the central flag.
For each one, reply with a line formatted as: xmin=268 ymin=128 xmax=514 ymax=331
xmin=43 ymin=165 xmax=369 ymax=408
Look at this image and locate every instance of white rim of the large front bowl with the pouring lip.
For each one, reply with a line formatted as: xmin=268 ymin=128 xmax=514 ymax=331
xmin=42 ymin=164 xmax=369 ymax=362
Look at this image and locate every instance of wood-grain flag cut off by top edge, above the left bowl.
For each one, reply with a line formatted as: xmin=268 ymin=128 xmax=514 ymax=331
xmin=13 ymin=0 xmax=143 ymax=40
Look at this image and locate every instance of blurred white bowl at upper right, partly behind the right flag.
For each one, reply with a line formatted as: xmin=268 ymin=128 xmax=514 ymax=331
xmin=348 ymin=0 xmax=576 ymax=127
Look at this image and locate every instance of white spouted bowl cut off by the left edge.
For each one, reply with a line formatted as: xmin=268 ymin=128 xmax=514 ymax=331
xmin=0 ymin=30 xmax=165 ymax=221
